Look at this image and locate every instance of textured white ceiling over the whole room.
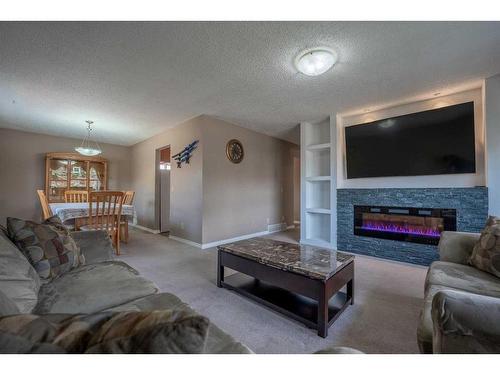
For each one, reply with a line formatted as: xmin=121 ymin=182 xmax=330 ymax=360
xmin=0 ymin=22 xmax=500 ymax=145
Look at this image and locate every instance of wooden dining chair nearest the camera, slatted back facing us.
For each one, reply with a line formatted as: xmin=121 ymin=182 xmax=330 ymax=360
xmin=80 ymin=191 xmax=123 ymax=255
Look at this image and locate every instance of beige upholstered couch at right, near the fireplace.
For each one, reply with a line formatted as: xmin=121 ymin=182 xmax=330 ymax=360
xmin=417 ymin=232 xmax=500 ymax=353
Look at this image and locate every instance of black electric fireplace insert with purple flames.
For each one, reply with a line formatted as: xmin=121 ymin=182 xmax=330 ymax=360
xmin=354 ymin=206 xmax=457 ymax=245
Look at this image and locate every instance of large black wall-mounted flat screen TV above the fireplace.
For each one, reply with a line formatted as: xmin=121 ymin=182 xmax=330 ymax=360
xmin=345 ymin=102 xmax=476 ymax=178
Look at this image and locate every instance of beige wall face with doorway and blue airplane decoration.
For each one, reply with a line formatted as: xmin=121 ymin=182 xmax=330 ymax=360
xmin=131 ymin=117 xmax=203 ymax=243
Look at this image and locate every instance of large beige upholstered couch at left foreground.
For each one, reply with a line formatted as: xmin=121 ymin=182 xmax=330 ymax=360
xmin=0 ymin=229 xmax=251 ymax=353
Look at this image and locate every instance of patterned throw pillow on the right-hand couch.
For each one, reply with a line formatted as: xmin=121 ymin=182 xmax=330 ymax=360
xmin=469 ymin=216 xmax=500 ymax=277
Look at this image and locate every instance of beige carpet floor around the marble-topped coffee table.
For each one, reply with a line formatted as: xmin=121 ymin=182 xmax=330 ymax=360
xmin=120 ymin=230 xmax=426 ymax=353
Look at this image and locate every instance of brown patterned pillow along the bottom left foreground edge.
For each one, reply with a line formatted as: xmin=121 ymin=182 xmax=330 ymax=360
xmin=0 ymin=310 xmax=210 ymax=354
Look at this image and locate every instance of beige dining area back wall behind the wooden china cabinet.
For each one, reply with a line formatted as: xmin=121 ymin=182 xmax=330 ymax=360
xmin=0 ymin=128 xmax=131 ymax=224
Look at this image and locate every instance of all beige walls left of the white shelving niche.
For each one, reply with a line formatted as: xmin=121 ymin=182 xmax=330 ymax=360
xmin=0 ymin=116 xmax=299 ymax=247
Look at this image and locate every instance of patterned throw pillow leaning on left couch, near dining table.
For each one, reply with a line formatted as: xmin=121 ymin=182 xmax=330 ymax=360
xmin=7 ymin=216 xmax=85 ymax=280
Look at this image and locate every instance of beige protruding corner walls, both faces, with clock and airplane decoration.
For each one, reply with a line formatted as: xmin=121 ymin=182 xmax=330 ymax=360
xmin=131 ymin=116 xmax=299 ymax=244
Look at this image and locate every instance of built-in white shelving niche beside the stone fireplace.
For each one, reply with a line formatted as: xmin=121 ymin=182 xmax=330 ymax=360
xmin=300 ymin=118 xmax=337 ymax=248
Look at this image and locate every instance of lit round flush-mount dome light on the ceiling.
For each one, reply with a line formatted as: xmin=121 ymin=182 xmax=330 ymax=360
xmin=295 ymin=47 xmax=337 ymax=76
